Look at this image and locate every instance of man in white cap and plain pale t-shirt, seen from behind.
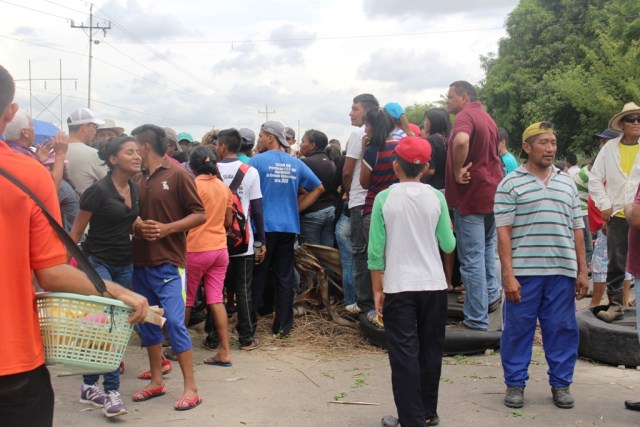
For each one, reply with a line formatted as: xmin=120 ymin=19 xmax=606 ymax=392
xmin=66 ymin=108 xmax=107 ymax=195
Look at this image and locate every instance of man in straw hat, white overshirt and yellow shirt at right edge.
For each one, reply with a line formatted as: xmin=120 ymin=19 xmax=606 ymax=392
xmin=589 ymin=102 xmax=640 ymax=322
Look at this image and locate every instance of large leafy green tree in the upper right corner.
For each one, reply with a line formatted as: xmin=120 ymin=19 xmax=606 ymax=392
xmin=480 ymin=0 xmax=640 ymax=156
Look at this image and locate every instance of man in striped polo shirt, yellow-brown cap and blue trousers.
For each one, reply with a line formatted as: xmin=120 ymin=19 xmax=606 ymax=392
xmin=494 ymin=122 xmax=589 ymax=409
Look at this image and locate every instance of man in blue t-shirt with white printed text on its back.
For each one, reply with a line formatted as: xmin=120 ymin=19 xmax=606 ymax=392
xmin=249 ymin=121 xmax=324 ymax=337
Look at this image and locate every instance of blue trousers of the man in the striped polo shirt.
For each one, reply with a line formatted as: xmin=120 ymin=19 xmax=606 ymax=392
xmin=500 ymin=275 xmax=579 ymax=387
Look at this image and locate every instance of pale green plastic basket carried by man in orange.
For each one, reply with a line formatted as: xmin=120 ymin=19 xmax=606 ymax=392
xmin=36 ymin=292 xmax=134 ymax=376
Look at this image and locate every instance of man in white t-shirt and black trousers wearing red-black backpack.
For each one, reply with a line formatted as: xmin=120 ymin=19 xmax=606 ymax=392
xmin=214 ymin=129 xmax=266 ymax=351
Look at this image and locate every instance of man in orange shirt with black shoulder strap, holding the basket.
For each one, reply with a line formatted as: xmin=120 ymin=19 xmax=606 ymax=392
xmin=0 ymin=65 xmax=149 ymax=427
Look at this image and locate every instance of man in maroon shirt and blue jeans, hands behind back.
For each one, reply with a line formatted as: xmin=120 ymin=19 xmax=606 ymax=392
xmin=445 ymin=81 xmax=503 ymax=331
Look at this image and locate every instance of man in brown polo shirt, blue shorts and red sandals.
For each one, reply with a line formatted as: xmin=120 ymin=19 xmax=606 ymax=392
xmin=131 ymin=125 xmax=206 ymax=411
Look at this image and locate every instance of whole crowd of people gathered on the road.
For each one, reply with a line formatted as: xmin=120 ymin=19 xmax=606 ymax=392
xmin=0 ymin=60 xmax=640 ymax=427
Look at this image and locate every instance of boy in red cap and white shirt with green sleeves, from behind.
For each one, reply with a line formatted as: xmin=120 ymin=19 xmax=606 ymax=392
xmin=369 ymin=136 xmax=455 ymax=427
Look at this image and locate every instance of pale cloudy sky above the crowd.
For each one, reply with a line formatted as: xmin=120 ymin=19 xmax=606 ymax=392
xmin=0 ymin=0 xmax=518 ymax=141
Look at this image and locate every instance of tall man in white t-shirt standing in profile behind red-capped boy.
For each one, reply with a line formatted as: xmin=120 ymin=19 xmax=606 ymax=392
xmin=342 ymin=93 xmax=380 ymax=313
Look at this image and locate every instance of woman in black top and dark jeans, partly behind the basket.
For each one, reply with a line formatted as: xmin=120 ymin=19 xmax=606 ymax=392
xmin=69 ymin=137 xmax=142 ymax=417
